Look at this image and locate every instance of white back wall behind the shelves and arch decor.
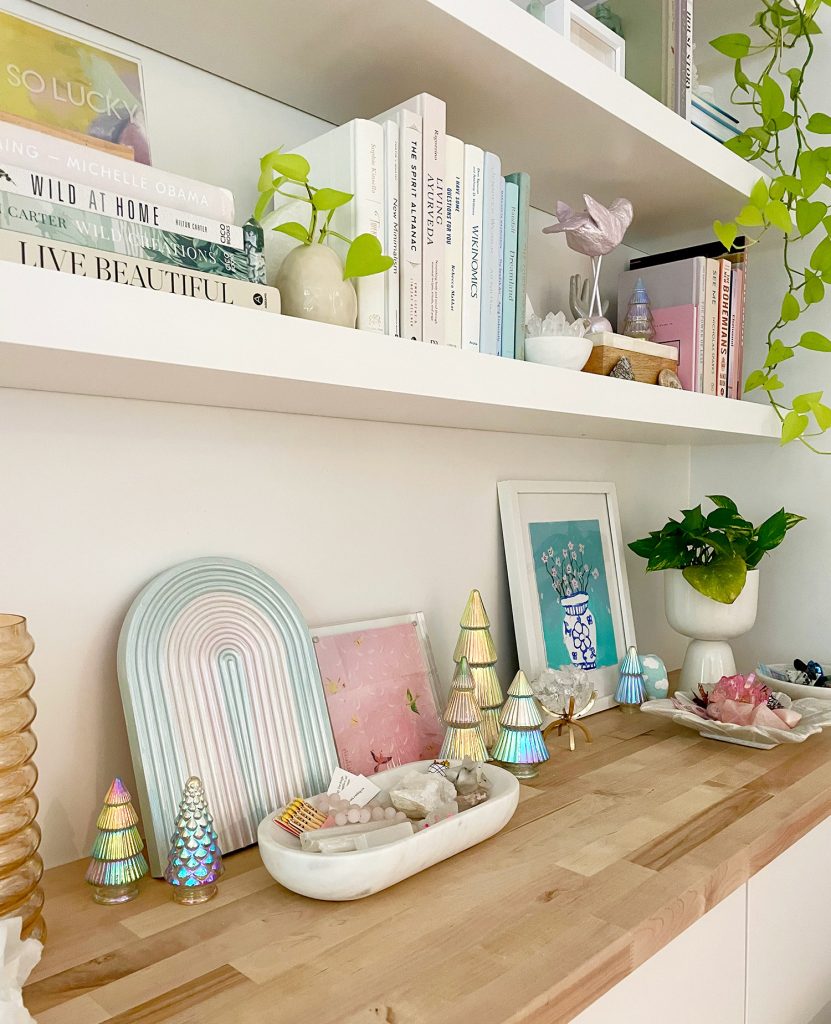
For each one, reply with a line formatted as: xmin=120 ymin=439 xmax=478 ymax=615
xmin=0 ymin=0 xmax=689 ymax=864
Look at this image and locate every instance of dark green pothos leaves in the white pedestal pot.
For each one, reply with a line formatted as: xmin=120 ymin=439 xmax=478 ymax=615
xmin=629 ymin=495 xmax=804 ymax=604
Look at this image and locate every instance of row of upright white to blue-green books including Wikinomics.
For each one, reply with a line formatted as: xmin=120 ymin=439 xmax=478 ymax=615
xmin=267 ymin=93 xmax=530 ymax=358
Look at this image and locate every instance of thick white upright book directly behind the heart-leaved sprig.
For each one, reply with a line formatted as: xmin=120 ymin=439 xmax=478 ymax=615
xmin=265 ymin=118 xmax=386 ymax=334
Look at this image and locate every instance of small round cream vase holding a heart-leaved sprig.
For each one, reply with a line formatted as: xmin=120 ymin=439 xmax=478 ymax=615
xmin=276 ymin=244 xmax=358 ymax=327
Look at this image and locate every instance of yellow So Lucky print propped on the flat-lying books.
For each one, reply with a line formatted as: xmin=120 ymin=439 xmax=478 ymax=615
xmin=0 ymin=11 xmax=150 ymax=164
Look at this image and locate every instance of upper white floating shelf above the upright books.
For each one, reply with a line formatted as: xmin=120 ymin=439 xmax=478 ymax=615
xmin=34 ymin=0 xmax=759 ymax=251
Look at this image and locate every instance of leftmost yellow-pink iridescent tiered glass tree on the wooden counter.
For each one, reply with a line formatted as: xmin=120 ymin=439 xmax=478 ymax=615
xmin=86 ymin=778 xmax=147 ymax=903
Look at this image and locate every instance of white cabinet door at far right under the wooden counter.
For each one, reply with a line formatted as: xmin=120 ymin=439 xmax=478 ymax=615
xmin=747 ymin=818 xmax=831 ymax=1024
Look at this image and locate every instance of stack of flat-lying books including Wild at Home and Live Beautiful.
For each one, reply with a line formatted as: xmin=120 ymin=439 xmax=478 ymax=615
xmin=0 ymin=117 xmax=279 ymax=312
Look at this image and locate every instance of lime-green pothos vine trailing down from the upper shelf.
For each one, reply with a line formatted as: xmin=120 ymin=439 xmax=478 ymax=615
xmin=710 ymin=0 xmax=831 ymax=455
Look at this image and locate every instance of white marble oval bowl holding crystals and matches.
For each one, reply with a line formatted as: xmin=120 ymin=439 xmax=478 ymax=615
xmin=257 ymin=761 xmax=519 ymax=900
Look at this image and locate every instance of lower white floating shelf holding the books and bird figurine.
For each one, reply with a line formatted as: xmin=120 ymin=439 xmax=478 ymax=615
xmin=0 ymin=263 xmax=778 ymax=444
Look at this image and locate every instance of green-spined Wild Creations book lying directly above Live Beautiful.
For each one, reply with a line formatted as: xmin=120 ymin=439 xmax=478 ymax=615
xmin=0 ymin=190 xmax=265 ymax=285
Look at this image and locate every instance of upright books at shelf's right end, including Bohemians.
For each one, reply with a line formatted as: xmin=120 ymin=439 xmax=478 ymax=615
xmin=617 ymin=239 xmax=747 ymax=398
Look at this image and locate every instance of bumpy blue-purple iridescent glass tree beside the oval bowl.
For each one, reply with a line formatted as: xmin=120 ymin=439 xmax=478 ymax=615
xmin=165 ymin=775 xmax=222 ymax=904
